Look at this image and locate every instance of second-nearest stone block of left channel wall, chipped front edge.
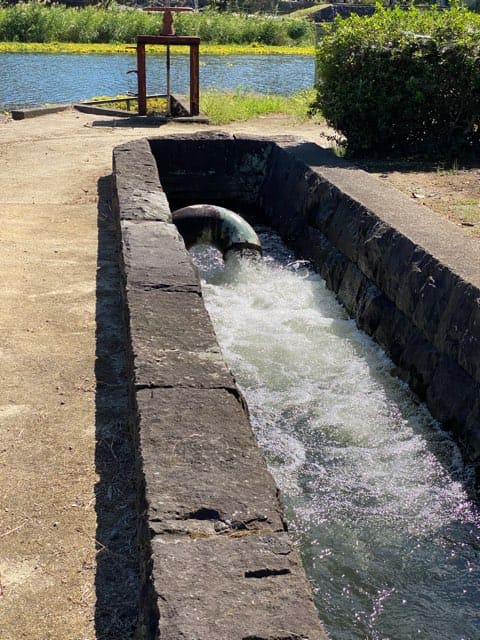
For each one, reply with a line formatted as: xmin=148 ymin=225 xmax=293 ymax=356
xmin=137 ymin=388 xmax=284 ymax=531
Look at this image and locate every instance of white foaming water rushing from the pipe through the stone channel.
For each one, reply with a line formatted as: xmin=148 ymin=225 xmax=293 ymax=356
xmin=190 ymin=234 xmax=480 ymax=640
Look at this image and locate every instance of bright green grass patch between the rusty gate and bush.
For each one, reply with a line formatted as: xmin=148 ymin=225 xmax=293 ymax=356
xmin=200 ymin=89 xmax=322 ymax=125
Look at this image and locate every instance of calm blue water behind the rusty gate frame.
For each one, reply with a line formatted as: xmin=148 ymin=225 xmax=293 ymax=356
xmin=0 ymin=53 xmax=314 ymax=110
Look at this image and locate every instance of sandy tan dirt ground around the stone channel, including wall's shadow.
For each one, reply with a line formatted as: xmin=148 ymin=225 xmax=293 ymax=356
xmin=0 ymin=110 xmax=480 ymax=640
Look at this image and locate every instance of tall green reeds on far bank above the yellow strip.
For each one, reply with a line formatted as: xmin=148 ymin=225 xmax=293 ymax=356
xmin=0 ymin=2 xmax=314 ymax=46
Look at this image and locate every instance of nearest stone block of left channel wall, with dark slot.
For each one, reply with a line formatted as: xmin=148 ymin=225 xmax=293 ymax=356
xmin=153 ymin=534 xmax=326 ymax=640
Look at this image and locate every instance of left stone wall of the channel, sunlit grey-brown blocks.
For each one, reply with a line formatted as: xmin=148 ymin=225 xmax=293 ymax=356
xmin=114 ymin=141 xmax=326 ymax=640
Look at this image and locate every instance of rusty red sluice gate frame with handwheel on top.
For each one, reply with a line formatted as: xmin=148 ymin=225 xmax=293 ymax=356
xmin=136 ymin=6 xmax=200 ymax=116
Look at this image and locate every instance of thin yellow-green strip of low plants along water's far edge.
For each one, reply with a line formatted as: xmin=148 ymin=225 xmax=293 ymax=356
xmin=0 ymin=42 xmax=315 ymax=56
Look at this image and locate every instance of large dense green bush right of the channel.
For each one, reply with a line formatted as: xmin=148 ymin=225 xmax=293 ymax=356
xmin=314 ymin=7 xmax=480 ymax=157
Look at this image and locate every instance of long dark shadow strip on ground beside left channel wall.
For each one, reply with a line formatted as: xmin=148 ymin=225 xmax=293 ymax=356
xmin=95 ymin=176 xmax=140 ymax=640
